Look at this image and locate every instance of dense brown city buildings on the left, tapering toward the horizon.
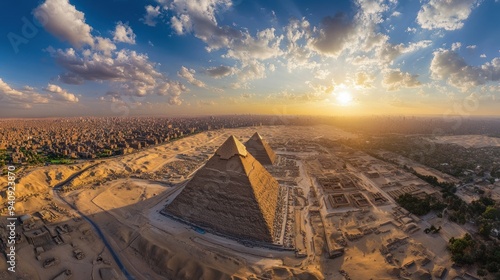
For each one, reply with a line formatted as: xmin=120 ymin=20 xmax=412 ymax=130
xmin=0 ymin=116 xmax=292 ymax=165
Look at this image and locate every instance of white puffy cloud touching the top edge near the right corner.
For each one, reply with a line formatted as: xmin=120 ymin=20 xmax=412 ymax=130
xmin=417 ymin=0 xmax=480 ymax=30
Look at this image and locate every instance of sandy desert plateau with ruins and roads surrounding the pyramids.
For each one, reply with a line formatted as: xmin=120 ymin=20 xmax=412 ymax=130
xmin=0 ymin=126 xmax=476 ymax=280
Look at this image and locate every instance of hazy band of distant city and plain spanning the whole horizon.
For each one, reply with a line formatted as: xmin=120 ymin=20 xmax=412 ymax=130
xmin=0 ymin=115 xmax=500 ymax=166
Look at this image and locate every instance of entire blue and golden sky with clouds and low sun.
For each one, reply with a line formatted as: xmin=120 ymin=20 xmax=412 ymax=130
xmin=0 ymin=0 xmax=500 ymax=117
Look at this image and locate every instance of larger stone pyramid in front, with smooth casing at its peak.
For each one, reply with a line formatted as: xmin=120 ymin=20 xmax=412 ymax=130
xmin=165 ymin=136 xmax=279 ymax=242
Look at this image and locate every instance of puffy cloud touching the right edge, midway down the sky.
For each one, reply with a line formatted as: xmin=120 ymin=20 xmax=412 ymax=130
xmin=430 ymin=49 xmax=500 ymax=90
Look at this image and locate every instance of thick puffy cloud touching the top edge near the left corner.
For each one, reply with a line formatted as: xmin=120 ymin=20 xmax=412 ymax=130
xmin=33 ymin=0 xmax=94 ymax=48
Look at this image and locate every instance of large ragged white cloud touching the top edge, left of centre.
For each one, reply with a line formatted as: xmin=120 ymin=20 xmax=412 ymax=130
xmin=169 ymin=0 xmax=284 ymax=80
